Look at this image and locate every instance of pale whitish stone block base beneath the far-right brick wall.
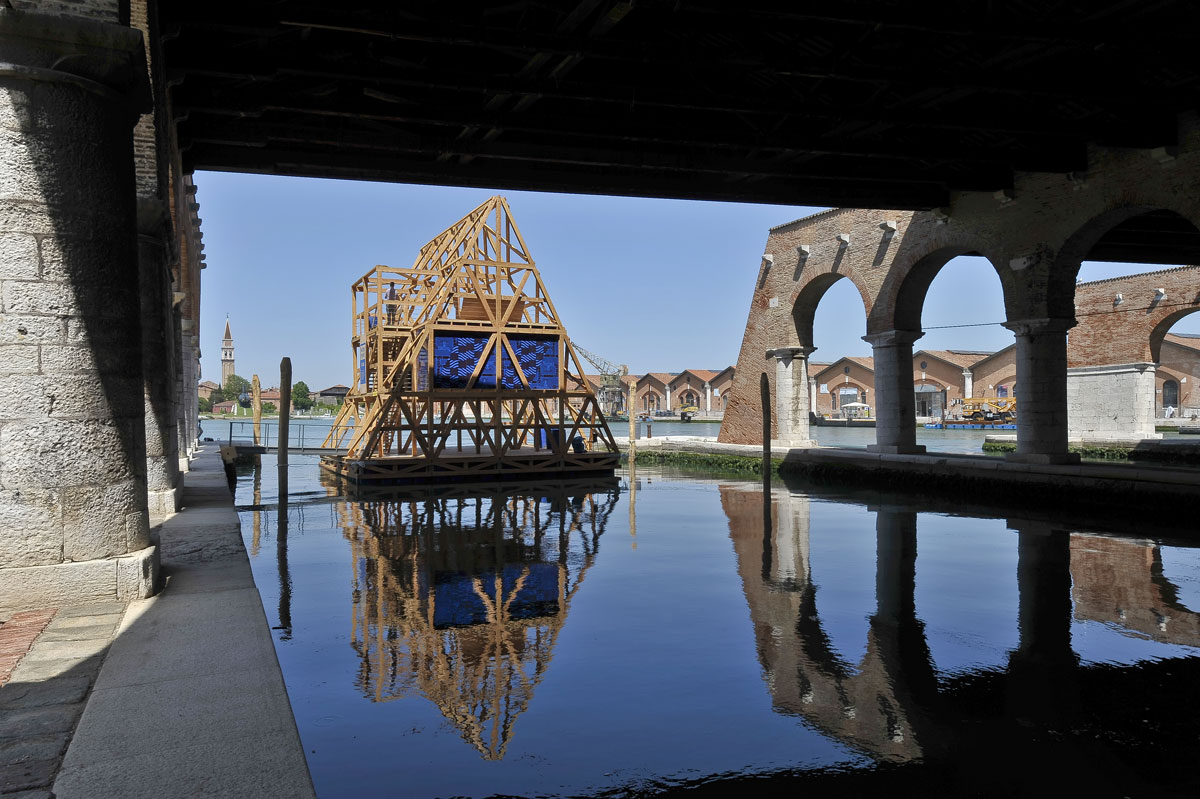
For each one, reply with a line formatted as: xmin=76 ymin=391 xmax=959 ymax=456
xmin=1070 ymin=364 xmax=1163 ymax=441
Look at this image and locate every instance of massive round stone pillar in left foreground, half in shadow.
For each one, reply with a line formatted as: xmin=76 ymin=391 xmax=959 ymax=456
xmin=0 ymin=7 xmax=157 ymax=608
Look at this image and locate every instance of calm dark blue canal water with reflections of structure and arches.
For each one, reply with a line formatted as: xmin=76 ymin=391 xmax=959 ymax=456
xmin=231 ymin=456 xmax=1200 ymax=797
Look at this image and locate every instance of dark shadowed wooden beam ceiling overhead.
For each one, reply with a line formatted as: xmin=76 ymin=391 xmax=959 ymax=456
xmin=158 ymin=0 xmax=1200 ymax=221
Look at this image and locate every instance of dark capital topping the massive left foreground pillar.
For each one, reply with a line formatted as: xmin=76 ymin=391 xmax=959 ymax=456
xmin=0 ymin=7 xmax=152 ymax=112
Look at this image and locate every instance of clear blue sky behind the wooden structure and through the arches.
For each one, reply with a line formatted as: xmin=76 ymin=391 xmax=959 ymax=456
xmin=196 ymin=173 xmax=1200 ymax=390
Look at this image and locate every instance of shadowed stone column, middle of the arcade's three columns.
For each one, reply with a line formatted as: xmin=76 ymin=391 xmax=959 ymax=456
xmin=863 ymin=330 xmax=925 ymax=453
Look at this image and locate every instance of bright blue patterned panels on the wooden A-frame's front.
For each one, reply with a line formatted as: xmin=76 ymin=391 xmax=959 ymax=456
xmin=433 ymin=336 xmax=558 ymax=390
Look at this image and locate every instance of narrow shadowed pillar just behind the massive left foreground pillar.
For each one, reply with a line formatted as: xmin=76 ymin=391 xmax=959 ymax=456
xmin=138 ymin=199 xmax=179 ymax=517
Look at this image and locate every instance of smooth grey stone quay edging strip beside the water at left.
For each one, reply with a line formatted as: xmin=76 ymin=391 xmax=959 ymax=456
xmin=53 ymin=445 xmax=316 ymax=799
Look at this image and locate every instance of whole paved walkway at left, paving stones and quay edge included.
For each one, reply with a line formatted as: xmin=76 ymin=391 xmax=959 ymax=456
xmin=0 ymin=445 xmax=314 ymax=799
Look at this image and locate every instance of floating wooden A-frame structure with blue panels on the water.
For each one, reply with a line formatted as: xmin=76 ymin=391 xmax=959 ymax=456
xmin=323 ymin=197 xmax=618 ymax=485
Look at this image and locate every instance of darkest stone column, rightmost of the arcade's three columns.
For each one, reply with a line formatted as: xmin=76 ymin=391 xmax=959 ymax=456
xmin=1004 ymin=319 xmax=1079 ymax=463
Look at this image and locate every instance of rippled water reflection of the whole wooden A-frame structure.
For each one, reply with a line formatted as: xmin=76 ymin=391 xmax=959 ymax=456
xmin=338 ymin=481 xmax=618 ymax=759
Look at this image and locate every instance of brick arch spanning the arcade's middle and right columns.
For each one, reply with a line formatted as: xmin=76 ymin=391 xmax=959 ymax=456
xmin=866 ymin=229 xmax=1013 ymax=334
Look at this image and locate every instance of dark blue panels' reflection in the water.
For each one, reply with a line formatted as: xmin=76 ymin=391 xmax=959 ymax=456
xmin=433 ymin=563 xmax=558 ymax=627
